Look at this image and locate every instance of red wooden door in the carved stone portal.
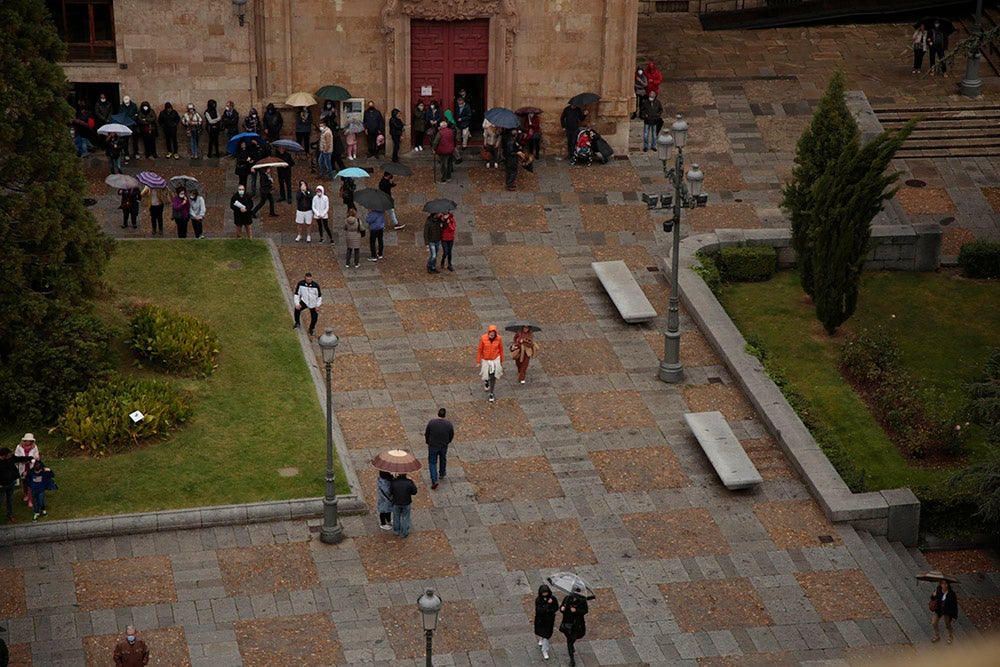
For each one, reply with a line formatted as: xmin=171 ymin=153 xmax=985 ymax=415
xmin=410 ymin=19 xmax=490 ymax=109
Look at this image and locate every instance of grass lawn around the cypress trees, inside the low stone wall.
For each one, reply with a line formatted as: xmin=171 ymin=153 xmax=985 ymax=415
xmin=723 ymin=272 xmax=1000 ymax=490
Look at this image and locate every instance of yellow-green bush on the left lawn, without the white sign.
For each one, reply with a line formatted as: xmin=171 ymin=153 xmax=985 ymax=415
xmin=128 ymin=305 xmax=219 ymax=376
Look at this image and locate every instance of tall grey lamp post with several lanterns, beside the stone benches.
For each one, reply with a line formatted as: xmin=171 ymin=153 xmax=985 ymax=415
xmin=644 ymin=114 xmax=708 ymax=382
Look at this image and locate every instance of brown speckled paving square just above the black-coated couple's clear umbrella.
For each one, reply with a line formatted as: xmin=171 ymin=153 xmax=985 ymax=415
xmin=490 ymin=519 xmax=597 ymax=572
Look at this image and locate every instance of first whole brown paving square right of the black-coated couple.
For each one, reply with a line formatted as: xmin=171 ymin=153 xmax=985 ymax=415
xmin=660 ymin=577 xmax=773 ymax=632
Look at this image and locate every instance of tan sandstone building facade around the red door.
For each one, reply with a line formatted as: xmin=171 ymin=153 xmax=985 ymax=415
xmin=58 ymin=0 xmax=639 ymax=152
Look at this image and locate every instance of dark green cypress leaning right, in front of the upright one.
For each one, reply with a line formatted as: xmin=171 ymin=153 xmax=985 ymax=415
xmin=809 ymin=119 xmax=918 ymax=335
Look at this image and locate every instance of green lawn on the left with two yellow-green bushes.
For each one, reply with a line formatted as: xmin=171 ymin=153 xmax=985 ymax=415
xmin=0 ymin=240 xmax=348 ymax=520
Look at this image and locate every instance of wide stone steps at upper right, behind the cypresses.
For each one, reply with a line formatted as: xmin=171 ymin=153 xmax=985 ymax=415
xmin=872 ymin=104 xmax=1000 ymax=159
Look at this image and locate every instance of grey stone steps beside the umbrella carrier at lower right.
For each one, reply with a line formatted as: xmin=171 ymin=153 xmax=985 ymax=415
xmin=837 ymin=526 xmax=979 ymax=644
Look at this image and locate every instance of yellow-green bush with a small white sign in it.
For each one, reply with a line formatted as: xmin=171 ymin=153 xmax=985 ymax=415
xmin=58 ymin=376 xmax=191 ymax=455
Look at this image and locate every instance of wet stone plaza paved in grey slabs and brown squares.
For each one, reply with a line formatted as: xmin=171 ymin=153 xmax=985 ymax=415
xmin=0 ymin=17 xmax=1000 ymax=667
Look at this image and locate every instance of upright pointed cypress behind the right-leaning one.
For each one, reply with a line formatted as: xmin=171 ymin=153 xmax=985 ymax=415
xmin=781 ymin=70 xmax=858 ymax=296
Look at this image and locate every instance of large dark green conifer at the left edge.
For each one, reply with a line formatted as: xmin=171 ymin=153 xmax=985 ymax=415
xmin=0 ymin=0 xmax=112 ymax=423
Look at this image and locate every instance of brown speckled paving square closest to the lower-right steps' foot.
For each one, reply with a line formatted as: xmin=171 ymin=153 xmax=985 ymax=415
xmin=795 ymin=570 xmax=892 ymax=623
